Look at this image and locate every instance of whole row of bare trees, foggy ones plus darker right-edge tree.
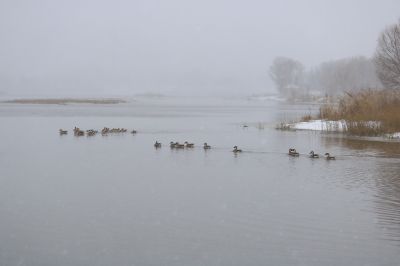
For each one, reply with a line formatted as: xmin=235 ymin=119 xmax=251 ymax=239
xmin=269 ymin=21 xmax=400 ymax=98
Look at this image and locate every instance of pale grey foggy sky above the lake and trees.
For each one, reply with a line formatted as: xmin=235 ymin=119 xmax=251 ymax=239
xmin=0 ymin=0 xmax=400 ymax=96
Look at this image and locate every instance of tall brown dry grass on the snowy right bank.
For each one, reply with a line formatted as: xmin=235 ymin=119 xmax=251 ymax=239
xmin=319 ymin=90 xmax=400 ymax=136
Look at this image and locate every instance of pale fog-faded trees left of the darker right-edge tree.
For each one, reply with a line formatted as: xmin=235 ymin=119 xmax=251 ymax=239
xmin=270 ymin=56 xmax=382 ymax=98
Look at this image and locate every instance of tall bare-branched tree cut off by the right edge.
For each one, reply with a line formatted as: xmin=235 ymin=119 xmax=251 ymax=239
xmin=374 ymin=21 xmax=400 ymax=89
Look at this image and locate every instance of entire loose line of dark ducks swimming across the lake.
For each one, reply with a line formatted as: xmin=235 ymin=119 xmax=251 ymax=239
xmin=59 ymin=127 xmax=336 ymax=160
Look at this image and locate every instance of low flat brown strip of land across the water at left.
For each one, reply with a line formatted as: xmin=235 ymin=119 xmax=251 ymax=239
xmin=2 ymin=98 xmax=126 ymax=105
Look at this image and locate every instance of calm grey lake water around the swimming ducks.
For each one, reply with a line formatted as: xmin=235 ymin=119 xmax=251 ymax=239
xmin=0 ymin=98 xmax=400 ymax=266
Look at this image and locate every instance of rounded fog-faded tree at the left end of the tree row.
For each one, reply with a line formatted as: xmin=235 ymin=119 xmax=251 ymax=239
xmin=269 ymin=57 xmax=304 ymax=97
